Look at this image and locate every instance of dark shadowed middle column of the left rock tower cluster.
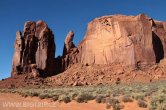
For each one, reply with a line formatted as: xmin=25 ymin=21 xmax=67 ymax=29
xmin=22 ymin=21 xmax=37 ymax=68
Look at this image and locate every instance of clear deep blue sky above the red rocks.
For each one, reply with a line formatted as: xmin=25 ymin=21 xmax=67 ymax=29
xmin=0 ymin=0 xmax=166 ymax=79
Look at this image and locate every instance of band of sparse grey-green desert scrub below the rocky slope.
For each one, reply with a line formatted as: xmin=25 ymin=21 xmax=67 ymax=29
xmin=0 ymin=81 xmax=166 ymax=110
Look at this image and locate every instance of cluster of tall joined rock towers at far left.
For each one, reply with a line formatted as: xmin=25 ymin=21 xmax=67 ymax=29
xmin=12 ymin=21 xmax=55 ymax=76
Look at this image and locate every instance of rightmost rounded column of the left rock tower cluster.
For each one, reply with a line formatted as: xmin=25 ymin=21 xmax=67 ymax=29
xmin=36 ymin=21 xmax=55 ymax=74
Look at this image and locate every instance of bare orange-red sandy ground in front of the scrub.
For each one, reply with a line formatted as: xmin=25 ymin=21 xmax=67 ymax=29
xmin=0 ymin=93 xmax=148 ymax=110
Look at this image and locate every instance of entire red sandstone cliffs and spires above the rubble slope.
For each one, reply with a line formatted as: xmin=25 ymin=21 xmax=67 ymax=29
xmin=12 ymin=14 xmax=166 ymax=81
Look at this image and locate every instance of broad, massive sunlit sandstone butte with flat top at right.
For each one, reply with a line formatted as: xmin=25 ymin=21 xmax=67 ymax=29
xmin=79 ymin=14 xmax=166 ymax=67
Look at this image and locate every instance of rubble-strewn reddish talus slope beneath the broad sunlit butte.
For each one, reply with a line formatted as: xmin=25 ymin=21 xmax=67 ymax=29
xmin=46 ymin=60 xmax=166 ymax=86
